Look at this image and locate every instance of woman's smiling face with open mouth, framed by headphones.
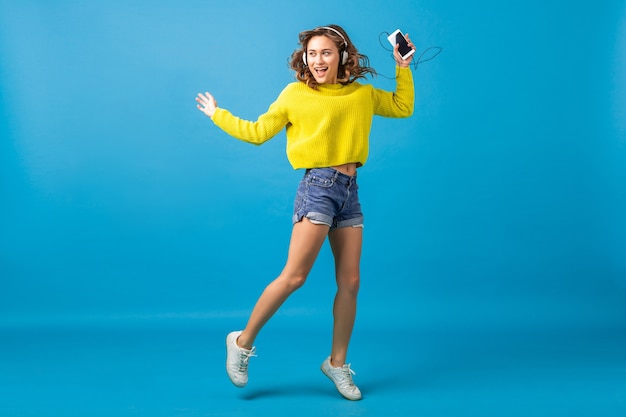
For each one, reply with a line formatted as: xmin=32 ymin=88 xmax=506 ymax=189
xmin=306 ymin=36 xmax=339 ymax=84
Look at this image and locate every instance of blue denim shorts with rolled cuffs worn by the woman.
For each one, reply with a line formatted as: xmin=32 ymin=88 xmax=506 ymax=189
xmin=293 ymin=168 xmax=363 ymax=229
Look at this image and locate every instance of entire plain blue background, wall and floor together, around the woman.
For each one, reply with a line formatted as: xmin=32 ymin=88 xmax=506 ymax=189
xmin=0 ymin=0 xmax=626 ymax=416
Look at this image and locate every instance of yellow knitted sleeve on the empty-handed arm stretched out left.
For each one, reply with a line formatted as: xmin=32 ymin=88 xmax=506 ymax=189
xmin=212 ymin=89 xmax=289 ymax=145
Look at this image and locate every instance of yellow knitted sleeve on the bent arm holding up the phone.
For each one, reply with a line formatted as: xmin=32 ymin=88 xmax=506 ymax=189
xmin=374 ymin=67 xmax=415 ymax=117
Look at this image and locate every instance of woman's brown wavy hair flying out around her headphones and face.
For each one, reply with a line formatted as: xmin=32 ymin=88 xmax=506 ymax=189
xmin=289 ymin=25 xmax=376 ymax=89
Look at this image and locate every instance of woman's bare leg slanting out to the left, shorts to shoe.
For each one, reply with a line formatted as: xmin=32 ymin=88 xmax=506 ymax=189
xmin=237 ymin=217 xmax=329 ymax=349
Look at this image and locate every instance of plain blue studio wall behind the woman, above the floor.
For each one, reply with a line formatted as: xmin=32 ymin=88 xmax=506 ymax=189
xmin=0 ymin=0 xmax=626 ymax=332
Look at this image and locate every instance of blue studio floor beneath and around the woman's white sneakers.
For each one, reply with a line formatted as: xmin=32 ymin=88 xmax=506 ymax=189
xmin=0 ymin=319 xmax=626 ymax=417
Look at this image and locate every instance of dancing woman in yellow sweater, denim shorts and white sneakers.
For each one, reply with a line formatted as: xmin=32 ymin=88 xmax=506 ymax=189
xmin=196 ymin=25 xmax=414 ymax=400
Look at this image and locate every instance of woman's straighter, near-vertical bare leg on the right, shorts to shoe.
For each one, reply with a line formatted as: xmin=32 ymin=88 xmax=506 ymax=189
xmin=328 ymin=227 xmax=363 ymax=367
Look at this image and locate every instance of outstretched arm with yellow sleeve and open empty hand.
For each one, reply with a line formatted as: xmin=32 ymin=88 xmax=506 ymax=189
xmin=196 ymin=92 xmax=288 ymax=145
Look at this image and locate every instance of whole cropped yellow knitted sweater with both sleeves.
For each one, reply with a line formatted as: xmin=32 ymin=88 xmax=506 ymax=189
xmin=212 ymin=67 xmax=414 ymax=169
